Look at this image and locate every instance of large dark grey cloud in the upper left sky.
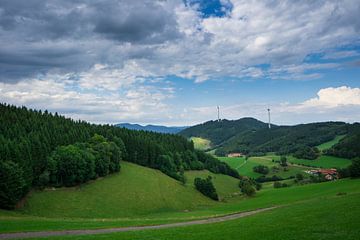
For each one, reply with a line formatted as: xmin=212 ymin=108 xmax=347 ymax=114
xmin=0 ymin=0 xmax=180 ymax=82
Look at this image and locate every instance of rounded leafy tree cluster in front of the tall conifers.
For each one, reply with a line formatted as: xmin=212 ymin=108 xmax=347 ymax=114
xmin=43 ymin=134 xmax=121 ymax=187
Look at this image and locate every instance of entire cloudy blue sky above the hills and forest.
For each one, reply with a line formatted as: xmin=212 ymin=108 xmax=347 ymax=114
xmin=0 ymin=0 xmax=360 ymax=126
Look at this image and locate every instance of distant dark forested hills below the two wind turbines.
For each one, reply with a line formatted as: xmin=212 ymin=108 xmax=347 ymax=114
xmin=180 ymin=118 xmax=360 ymax=158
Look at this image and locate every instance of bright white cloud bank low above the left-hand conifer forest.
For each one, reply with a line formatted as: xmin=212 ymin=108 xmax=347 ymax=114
xmin=0 ymin=74 xmax=173 ymax=123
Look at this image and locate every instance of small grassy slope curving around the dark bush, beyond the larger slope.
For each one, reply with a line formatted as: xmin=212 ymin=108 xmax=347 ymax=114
xmin=185 ymin=170 xmax=240 ymax=199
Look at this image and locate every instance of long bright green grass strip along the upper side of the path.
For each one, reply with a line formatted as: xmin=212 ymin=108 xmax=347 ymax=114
xmin=0 ymin=179 xmax=360 ymax=233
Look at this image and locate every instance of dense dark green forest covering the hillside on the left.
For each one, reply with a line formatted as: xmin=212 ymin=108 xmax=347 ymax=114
xmin=0 ymin=104 xmax=239 ymax=208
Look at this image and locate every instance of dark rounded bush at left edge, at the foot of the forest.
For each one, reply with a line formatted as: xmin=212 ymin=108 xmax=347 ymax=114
xmin=0 ymin=161 xmax=27 ymax=209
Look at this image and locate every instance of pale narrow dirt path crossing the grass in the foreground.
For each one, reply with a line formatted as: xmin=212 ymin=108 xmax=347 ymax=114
xmin=0 ymin=207 xmax=277 ymax=239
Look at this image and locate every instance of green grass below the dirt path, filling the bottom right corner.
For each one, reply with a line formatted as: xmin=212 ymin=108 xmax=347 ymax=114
xmin=26 ymin=185 xmax=360 ymax=240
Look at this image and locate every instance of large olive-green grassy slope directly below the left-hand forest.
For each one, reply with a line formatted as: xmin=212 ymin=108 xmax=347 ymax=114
xmin=16 ymin=162 xmax=213 ymax=218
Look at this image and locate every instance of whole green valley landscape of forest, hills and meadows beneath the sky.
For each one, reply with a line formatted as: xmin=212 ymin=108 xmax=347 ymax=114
xmin=0 ymin=105 xmax=360 ymax=239
